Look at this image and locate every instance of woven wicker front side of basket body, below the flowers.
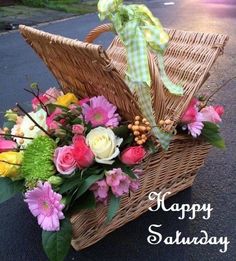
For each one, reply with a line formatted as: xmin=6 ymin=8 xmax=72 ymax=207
xmin=71 ymin=137 xmax=210 ymax=250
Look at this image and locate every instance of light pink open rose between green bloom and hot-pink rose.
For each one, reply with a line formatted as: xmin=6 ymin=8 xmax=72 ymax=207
xmin=54 ymin=146 xmax=77 ymax=175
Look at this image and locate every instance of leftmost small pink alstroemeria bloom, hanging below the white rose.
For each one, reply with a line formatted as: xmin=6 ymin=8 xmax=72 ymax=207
xmin=90 ymin=179 xmax=109 ymax=204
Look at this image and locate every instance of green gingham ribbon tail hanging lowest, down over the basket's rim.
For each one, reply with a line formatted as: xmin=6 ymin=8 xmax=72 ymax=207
xmin=135 ymin=85 xmax=172 ymax=150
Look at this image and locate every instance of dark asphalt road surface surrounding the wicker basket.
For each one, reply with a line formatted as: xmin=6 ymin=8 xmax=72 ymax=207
xmin=0 ymin=0 xmax=236 ymax=261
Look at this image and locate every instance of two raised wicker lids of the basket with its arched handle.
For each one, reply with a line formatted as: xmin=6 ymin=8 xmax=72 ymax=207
xmin=20 ymin=24 xmax=228 ymax=121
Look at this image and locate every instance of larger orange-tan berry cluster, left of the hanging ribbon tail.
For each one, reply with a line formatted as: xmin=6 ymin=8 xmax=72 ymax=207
xmin=128 ymin=116 xmax=151 ymax=145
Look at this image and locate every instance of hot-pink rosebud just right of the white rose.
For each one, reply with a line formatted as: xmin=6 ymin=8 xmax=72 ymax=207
xmin=120 ymin=146 xmax=146 ymax=165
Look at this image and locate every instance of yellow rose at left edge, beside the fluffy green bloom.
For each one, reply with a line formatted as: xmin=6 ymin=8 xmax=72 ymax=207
xmin=0 ymin=151 xmax=23 ymax=178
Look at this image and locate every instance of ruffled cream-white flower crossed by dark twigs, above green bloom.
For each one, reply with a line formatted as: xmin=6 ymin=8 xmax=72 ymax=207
xmin=11 ymin=109 xmax=47 ymax=148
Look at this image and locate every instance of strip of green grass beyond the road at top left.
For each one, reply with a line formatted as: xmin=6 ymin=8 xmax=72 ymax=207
xmin=22 ymin=0 xmax=98 ymax=14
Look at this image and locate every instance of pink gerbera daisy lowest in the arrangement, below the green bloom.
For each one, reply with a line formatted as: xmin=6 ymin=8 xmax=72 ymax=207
xmin=25 ymin=182 xmax=65 ymax=231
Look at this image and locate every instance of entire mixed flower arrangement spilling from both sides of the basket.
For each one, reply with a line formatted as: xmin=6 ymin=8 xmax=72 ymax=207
xmin=0 ymin=85 xmax=224 ymax=260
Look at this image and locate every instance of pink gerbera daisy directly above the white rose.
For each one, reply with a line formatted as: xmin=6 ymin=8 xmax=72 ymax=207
xmin=82 ymin=96 xmax=120 ymax=127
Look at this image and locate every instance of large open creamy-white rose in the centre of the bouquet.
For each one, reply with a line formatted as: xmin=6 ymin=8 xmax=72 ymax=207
xmin=86 ymin=127 xmax=123 ymax=164
